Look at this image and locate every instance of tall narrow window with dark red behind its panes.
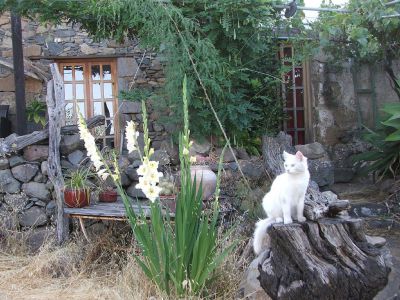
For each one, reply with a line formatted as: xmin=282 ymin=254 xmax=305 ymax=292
xmin=280 ymin=45 xmax=310 ymax=145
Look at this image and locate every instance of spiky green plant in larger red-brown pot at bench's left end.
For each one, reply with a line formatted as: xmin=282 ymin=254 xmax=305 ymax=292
xmin=64 ymin=168 xmax=90 ymax=208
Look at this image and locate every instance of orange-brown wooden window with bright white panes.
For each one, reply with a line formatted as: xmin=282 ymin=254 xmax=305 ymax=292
xmin=59 ymin=60 xmax=118 ymax=148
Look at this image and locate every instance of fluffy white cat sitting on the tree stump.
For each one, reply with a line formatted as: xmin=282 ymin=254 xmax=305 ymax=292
xmin=253 ymin=151 xmax=310 ymax=255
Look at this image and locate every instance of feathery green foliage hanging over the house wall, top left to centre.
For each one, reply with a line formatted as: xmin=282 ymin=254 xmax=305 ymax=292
xmin=3 ymin=0 xmax=282 ymax=149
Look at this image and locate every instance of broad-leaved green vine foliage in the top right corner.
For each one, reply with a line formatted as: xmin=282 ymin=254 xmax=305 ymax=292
xmin=297 ymin=0 xmax=400 ymax=97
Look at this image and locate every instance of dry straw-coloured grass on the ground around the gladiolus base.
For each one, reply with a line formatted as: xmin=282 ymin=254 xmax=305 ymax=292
xmin=0 ymin=221 xmax=248 ymax=300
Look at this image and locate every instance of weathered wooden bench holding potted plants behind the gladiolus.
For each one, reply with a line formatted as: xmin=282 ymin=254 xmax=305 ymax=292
xmin=64 ymin=197 xmax=175 ymax=242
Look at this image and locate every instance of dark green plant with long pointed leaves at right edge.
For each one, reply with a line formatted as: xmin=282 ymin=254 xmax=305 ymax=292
xmin=354 ymin=103 xmax=400 ymax=178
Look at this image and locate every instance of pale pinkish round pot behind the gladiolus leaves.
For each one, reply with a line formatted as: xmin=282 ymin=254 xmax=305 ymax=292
xmin=190 ymin=165 xmax=217 ymax=200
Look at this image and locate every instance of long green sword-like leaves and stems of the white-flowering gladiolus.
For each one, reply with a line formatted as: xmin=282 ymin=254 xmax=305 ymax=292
xmin=117 ymin=78 xmax=234 ymax=297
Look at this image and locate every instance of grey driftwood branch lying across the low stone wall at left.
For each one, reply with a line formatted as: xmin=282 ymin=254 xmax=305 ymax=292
xmin=0 ymin=116 xmax=105 ymax=155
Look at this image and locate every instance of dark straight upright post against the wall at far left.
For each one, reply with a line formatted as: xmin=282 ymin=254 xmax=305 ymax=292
xmin=11 ymin=12 xmax=26 ymax=135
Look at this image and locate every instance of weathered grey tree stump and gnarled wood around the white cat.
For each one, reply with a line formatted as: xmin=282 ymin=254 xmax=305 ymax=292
xmin=259 ymin=133 xmax=390 ymax=300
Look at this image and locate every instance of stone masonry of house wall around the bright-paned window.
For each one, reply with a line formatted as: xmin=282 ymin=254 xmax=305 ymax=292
xmin=0 ymin=13 xmax=167 ymax=148
